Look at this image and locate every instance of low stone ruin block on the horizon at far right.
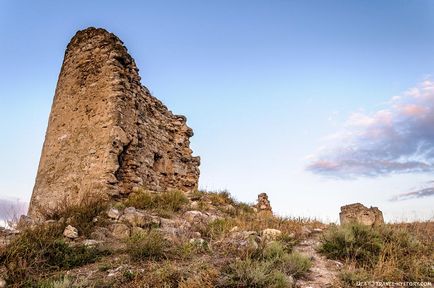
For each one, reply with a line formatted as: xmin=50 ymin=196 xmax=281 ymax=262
xmin=339 ymin=203 xmax=384 ymax=226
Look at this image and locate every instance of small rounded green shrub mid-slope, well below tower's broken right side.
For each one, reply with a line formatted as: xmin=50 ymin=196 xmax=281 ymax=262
xmin=126 ymin=230 xmax=170 ymax=260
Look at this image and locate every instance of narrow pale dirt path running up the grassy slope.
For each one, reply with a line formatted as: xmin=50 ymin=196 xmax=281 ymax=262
xmin=295 ymin=233 xmax=342 ymax=288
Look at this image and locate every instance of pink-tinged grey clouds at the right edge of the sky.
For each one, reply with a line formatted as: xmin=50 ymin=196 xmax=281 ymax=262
xmin=307 ymin=80 xmax=434 ymax=178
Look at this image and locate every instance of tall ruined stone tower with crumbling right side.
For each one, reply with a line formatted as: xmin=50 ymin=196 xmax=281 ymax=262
xmin=29 ymin=28 xmax=200 ymax=218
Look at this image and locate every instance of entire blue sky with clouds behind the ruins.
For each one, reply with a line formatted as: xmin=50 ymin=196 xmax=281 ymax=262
xmin=0 ymin=0 xmax=434 ymax=221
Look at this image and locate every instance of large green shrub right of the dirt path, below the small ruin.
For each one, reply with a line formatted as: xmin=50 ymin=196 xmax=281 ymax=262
xmin=320 ymin=224 xmax=383 ymax=267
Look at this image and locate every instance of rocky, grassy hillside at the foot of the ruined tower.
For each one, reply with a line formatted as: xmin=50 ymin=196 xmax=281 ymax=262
xmin=0 ymin=191 xmax=434 ymax=288
